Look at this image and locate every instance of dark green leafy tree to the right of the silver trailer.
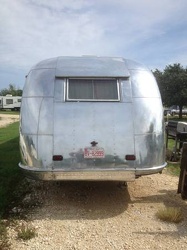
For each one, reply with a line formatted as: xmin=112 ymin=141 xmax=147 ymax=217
xmin=153 ymin=63 xmax=187 ymax=118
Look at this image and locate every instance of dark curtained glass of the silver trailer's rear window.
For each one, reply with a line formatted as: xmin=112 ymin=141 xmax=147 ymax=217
xmin=68 ymin=79 xmax=119 ymax=101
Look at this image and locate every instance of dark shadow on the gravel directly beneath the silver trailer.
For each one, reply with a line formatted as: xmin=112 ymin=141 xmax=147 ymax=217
xmin=28 ymin=181 xmax=131 ymax=220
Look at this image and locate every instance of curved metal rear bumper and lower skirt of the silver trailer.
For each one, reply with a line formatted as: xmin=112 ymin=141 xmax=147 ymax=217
xmin=19 ymin=163 xmax=166 ymax=181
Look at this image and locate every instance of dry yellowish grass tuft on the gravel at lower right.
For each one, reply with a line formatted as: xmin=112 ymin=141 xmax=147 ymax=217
xmin=156 ymin=207 xmax=183 ymax=223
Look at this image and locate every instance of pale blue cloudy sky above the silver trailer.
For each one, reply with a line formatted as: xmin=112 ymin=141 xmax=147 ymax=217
xmin=0 ymin=0 xmax=187 ymax=90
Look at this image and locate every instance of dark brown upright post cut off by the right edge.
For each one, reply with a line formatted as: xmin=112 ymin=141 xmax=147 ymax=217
xmin=177 ymin=142 xmax=187 ymax=199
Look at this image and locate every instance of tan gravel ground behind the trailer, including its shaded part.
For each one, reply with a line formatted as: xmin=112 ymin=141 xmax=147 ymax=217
xmin=6 ymin=170 xmax=187 ymax=250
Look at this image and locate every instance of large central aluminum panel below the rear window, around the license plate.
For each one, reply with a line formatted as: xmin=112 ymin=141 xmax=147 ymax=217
xmin=53 ymin=102 xmax=134 ymax=168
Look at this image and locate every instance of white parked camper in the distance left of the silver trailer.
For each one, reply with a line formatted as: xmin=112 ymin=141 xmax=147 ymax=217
xmin=0 ymin=95 xmax=21 ymax=110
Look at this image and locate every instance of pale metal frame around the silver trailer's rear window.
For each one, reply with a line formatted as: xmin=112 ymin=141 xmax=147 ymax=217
xmin=65 ymin=77 xmax=121 ymax=102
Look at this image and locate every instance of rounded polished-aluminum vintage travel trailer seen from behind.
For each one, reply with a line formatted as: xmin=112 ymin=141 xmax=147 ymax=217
xmin=19 ymin=56 xmax=166 ymax=181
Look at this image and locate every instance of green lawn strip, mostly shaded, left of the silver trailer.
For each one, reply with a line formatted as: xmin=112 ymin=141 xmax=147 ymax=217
xmin=0 ymin=122 xmax=23 ymax=218
